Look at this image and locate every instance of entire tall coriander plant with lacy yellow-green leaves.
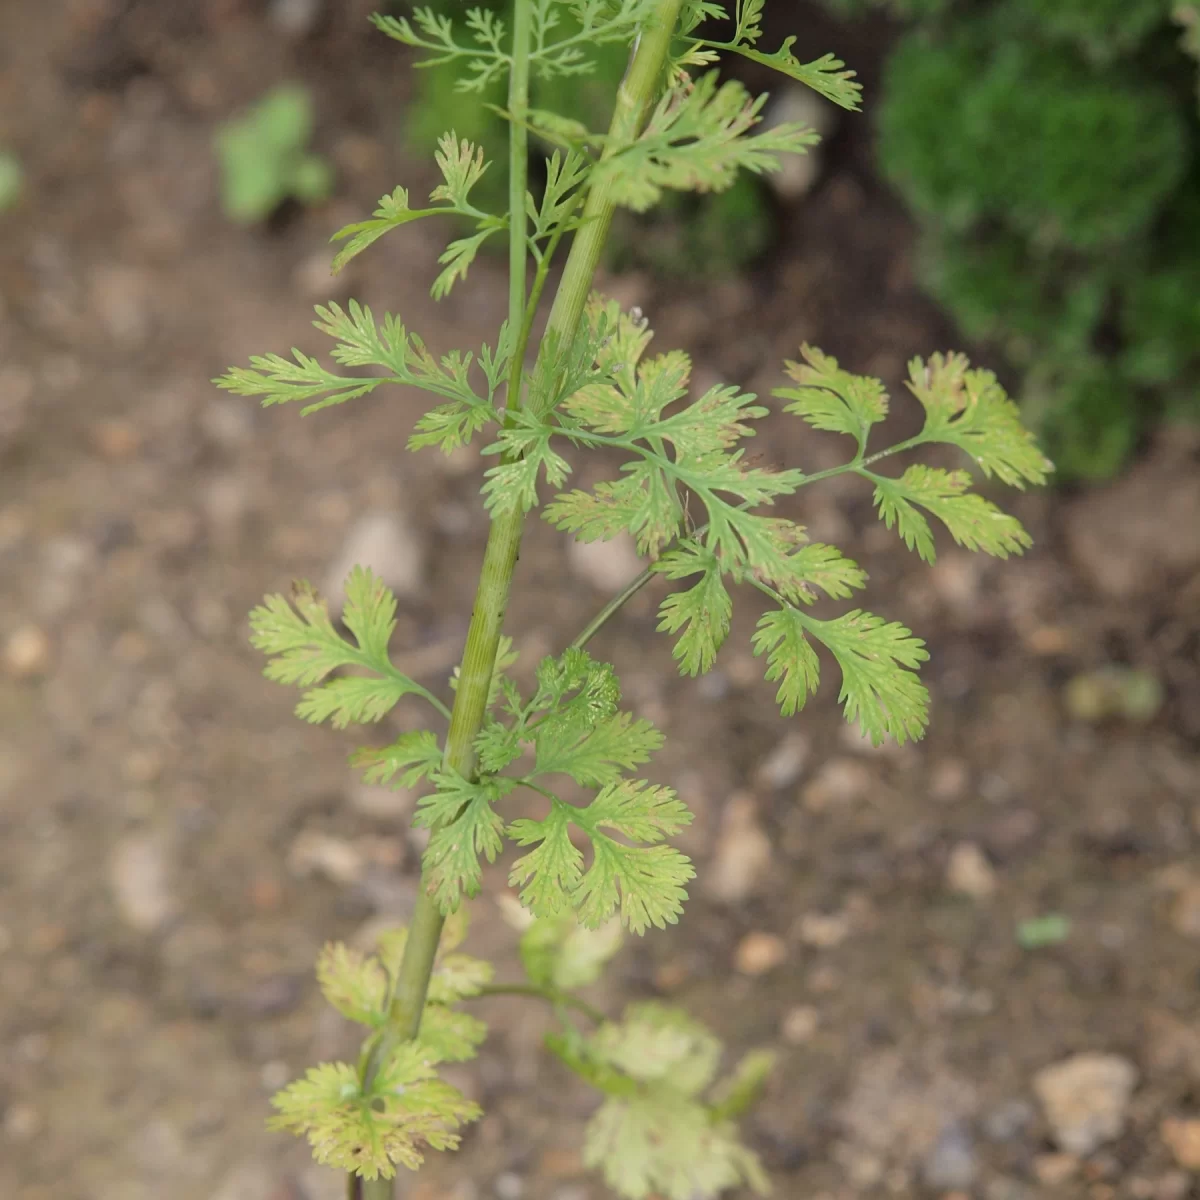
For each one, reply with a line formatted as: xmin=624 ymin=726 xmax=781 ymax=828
xmin=217 ymin=0 xmax=1050 ymax=1200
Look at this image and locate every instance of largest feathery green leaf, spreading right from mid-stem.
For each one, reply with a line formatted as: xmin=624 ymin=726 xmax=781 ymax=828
xmin=537 ymin=309 xmax=1050 ymax=739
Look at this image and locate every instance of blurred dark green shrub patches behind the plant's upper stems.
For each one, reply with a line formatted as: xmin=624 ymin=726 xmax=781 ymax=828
xmin=394 ymin=0 xmax=774 ymax=278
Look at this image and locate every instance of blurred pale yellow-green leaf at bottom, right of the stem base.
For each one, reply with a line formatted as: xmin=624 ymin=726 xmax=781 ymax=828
xmin=551 ymin=1004 xmax=769 ymax=1200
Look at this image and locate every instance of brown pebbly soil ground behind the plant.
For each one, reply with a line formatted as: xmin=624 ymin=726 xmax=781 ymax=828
xmin=0 ymin=7 xmax=1200 ymax=1200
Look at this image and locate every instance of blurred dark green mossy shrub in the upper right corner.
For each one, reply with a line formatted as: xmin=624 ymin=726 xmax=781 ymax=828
xmin=826 ymin=0 xmax=1200 ymax=478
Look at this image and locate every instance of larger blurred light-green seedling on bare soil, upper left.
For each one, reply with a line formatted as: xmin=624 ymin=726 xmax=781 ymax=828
xmin=215 ymin=85 xmax=334 ymax=224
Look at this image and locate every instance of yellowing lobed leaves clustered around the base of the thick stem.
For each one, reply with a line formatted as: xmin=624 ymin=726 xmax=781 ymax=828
xmin=271 ymin=929 xmax=492 ymax=1180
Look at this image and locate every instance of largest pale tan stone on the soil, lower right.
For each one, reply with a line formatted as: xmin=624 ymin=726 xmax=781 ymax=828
xmin=1033 ymin=1054 xmax=1138 ymax=1156
